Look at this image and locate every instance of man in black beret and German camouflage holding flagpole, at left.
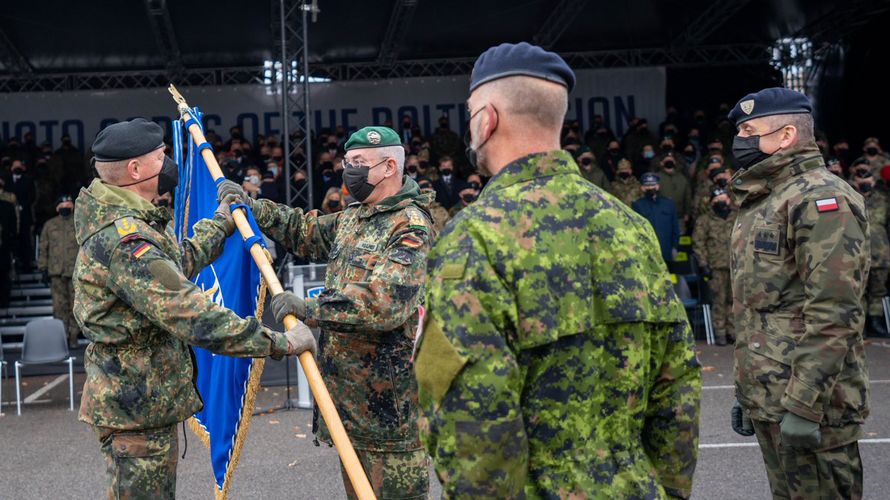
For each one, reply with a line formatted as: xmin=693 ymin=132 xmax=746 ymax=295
xmin=74 ymin=118 xmax=315 ymax=498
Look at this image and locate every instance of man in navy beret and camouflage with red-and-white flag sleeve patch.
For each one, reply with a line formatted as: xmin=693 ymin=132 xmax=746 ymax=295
xmin=730 ymin=88 xmax=870 ymax=498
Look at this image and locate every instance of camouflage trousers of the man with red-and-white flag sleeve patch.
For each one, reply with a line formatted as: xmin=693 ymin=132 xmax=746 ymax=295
xmin=753 ymin=420 xmax=862 ymax=500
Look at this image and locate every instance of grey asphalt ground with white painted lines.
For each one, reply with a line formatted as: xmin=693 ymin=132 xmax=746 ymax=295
xmin=0 ymin=343 xmax=890 ymax=500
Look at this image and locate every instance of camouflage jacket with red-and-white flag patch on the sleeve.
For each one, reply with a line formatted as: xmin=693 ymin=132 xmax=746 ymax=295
xmin=730 ymin=144 xmax=870 ymax=448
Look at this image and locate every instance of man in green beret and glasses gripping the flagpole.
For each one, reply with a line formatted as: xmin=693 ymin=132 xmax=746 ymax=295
xmin=227 ymin=127 xmax=435 ymax=499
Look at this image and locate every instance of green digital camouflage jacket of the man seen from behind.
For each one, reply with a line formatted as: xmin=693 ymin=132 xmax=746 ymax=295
xmin=415 ymin=151 xmax=701 ymax=498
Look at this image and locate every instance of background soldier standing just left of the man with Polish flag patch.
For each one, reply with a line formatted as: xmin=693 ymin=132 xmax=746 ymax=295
xmin=692 ymin=188 xmax=736 ymax=346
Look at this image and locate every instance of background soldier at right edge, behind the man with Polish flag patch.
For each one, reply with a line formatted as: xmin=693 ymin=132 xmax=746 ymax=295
xmin=850 ymin=170 xmax=890 ymax=337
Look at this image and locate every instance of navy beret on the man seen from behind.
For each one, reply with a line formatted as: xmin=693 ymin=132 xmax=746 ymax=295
xmin=470 ymin=42 xmax=575 ymax=93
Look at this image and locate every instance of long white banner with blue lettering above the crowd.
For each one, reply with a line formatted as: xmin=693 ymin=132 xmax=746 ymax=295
xmin=0 ymin=67 xmax=666 ymax=150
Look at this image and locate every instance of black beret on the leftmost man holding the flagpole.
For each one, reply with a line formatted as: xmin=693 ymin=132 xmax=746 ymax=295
xmin=92 ymin=118 xmax=164 ymax=161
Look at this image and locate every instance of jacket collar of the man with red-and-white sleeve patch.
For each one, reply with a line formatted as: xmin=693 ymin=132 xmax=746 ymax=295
xmin=732 ymin=142 xmax=825 ymax=205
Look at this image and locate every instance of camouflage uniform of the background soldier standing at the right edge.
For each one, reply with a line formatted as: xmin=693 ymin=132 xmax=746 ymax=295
xmin=863 ymin=190 xmax=890 ymax=318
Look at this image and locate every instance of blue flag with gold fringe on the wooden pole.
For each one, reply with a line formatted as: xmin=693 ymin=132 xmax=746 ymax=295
xmin=173 ymin=109 xmax=265 ymax=498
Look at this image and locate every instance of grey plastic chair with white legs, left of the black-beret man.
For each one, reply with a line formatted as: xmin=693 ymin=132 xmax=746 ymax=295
xmin=15 ymin=318 xmax=74 ymax=415
